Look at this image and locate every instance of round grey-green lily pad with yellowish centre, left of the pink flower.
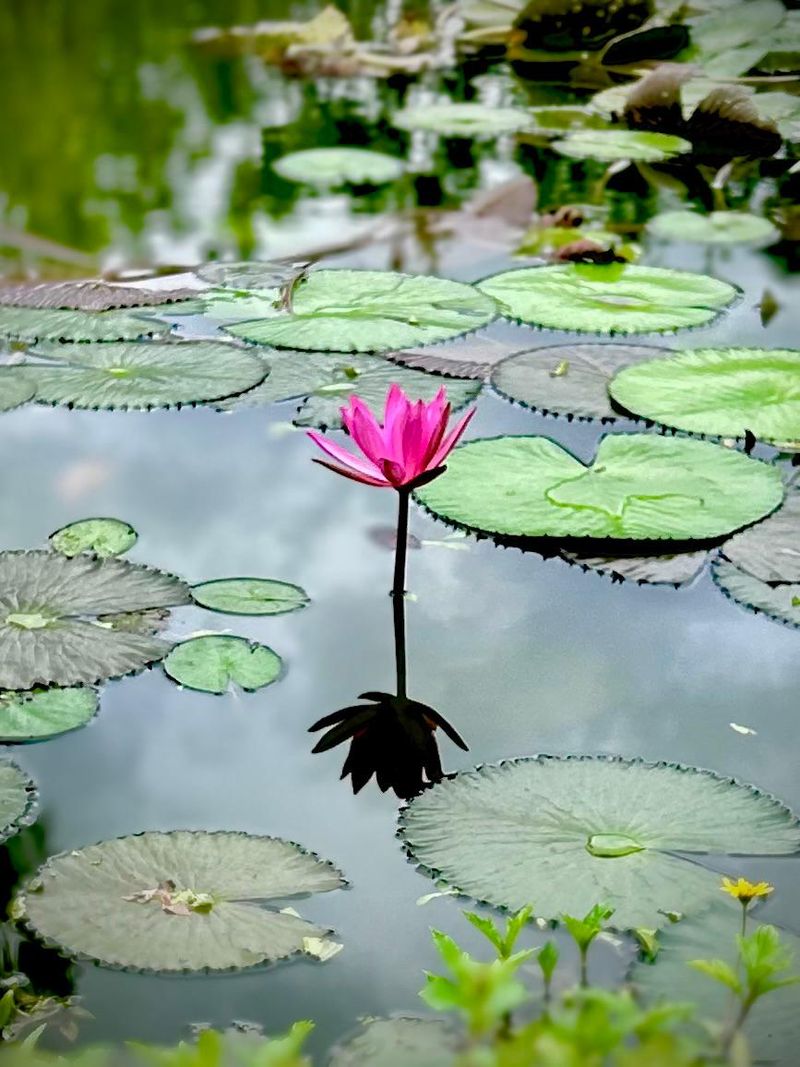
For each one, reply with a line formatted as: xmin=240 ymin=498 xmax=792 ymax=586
xmin=19 ymin=341 xmax=267 ymax=411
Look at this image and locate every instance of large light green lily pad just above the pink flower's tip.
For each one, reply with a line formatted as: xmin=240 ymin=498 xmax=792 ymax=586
xmin=224 ymin=270 xmax=497 ymax=352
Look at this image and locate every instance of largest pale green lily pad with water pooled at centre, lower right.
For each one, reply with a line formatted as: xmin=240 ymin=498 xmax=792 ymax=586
xmin=400 ymin=757 xmax=800 ymax=929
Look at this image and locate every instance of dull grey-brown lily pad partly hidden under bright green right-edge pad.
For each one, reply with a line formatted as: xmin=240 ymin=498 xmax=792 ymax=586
xmin=492 ymin=345 xmax=671 ymax=423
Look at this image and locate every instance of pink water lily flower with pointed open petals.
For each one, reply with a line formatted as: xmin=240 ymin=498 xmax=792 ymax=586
xmin=308 ymin=385 xmax=475 ymax=489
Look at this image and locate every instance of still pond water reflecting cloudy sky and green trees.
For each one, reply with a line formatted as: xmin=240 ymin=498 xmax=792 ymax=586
xmin=0 ymin=0 xmax=800 ymax=1051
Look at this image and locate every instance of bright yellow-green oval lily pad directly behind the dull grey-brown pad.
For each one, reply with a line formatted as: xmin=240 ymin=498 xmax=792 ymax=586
xmin=479 ymin=264 xmax=738 ymax=334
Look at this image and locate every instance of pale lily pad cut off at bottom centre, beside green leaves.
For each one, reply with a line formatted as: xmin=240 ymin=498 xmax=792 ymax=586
xmin=327 ymin=1018 xmax=463 ymax=1067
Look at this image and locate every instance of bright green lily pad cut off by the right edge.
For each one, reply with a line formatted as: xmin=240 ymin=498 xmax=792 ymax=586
xmin=609 ymin=348 xmax=800 ymax=443
